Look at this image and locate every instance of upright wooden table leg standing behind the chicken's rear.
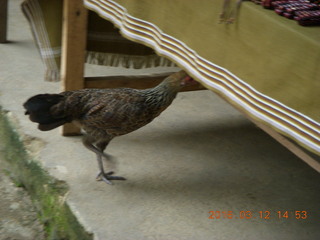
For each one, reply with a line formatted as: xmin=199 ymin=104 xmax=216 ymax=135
xmin=61 ymin=0 xmax=88 ymax=136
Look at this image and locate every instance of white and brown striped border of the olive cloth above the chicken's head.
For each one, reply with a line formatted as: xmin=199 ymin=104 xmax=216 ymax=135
xmin=84 ymin=0 xmax=320 ymax=155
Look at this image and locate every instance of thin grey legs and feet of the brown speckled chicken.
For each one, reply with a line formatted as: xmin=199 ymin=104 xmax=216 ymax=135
xmin=82 ymin=136 xmax=126 ymax=184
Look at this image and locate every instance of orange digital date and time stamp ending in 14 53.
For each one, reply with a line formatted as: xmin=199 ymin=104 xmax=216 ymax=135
xmin=208 ymin=210 xmax=308 ymax=220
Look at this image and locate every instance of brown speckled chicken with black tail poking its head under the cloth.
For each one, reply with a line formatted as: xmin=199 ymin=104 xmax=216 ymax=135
xmin=23 ymin=71 xmax=195 ymax=184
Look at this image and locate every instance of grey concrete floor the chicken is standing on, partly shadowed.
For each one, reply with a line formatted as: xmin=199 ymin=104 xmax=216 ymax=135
xmin=0 ymin=0 xmax=320 ymax=240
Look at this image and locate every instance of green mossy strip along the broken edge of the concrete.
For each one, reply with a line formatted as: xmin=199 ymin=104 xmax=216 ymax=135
xmin=0 ymin=109 xmax=93 ymax=240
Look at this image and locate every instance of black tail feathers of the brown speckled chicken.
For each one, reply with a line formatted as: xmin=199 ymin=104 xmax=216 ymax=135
xmin=23 ymin=94 xmax=69 ymax=131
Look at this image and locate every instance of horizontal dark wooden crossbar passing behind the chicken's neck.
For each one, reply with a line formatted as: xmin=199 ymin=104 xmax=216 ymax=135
xmin=85 ymin=73 xmax=206 ymax=92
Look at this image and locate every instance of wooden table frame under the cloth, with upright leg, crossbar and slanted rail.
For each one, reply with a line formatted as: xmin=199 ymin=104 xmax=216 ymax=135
xmin=61 ymin=0 xmax=320 ymax=172
